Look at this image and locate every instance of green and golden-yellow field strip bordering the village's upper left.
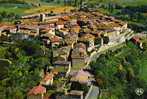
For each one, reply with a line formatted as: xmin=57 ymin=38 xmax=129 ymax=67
xmin=0 ymin=4 xmax=73 ymax=15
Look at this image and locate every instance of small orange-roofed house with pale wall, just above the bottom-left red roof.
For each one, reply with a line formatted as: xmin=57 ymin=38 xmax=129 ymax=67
xmin=40 ymin=73 xmax=54 ymax=86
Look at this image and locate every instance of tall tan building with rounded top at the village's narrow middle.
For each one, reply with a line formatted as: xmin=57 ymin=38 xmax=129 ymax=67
xmin=71 ymin=43 xmax=88 ymax=70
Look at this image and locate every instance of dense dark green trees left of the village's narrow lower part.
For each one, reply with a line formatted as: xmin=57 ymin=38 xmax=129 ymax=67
xmin=0 ymin=39 xmax=50 ymax=99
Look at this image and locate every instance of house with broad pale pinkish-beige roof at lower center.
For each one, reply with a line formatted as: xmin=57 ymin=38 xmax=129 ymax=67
xmin=69 ymin=70 xmax=94 ymax=85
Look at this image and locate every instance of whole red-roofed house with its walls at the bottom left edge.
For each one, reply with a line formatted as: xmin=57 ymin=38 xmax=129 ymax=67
xmin=27 ymin=85 xmax=46 ymax=99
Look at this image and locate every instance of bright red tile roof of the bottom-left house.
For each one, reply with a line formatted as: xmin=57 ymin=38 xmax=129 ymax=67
xmin=28 ymin=85 xmax=46 ymax=95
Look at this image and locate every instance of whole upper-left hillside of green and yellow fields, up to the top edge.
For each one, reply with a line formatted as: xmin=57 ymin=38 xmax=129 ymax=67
xmin=0 ymin=0 xmax=72 ymax=15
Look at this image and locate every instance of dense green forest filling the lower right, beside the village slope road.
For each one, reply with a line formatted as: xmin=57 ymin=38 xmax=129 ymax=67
xmin=91 ymin=41 xmax=147 ymax=99
